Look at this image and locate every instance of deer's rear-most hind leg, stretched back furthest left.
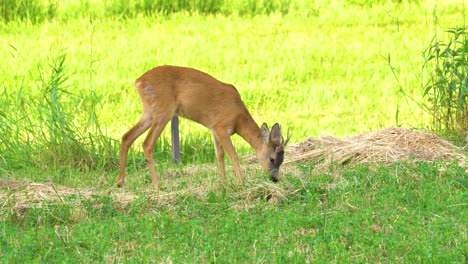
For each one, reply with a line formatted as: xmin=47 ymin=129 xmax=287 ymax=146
xmin=117 ymin=114 xmax=152 ymax=187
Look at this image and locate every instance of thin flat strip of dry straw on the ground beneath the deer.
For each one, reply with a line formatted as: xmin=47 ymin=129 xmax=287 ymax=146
xmin=0 ymin=178 xmax=299 ymax=213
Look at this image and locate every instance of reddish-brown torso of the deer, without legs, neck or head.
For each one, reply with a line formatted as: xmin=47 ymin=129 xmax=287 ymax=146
xmin=135 ymin=66 xmax=248 ymax=128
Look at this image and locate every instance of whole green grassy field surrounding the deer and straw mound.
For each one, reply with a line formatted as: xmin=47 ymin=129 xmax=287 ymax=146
xmin=0 ymin=0 xmax=468 ymax=263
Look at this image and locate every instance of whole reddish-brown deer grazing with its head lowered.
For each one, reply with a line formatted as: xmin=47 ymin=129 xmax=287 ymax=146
xmin=117 ymin=66 xmax=290 ymax=190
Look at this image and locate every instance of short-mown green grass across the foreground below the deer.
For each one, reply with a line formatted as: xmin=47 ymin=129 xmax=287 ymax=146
xmin=0 ymin=162 xmax=468 ymax=263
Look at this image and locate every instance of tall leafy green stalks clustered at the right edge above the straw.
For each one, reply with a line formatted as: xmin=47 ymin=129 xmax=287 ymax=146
xmin=423 ymin=25 xmax=468 ymax=135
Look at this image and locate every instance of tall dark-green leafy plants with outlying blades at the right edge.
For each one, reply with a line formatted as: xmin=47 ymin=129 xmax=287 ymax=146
xmin=387 ymin=2 xmax=468 ymax=136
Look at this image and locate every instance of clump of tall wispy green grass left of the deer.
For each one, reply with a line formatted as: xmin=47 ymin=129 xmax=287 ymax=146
xmin=0 ymin=52 xmax=116 ymax=171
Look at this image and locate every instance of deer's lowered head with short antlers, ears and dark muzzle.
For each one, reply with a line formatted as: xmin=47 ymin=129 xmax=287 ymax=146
xmin=257 ymin=123 xmax=291 ymax=182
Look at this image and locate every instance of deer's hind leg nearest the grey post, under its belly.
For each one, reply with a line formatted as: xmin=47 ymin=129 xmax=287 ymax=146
xmin=143 ymin=111 xmax=174 ymax=191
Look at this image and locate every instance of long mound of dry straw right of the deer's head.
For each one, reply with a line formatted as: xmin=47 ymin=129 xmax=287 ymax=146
xmin=289 ymin=127 xmax=466 ymax=166
